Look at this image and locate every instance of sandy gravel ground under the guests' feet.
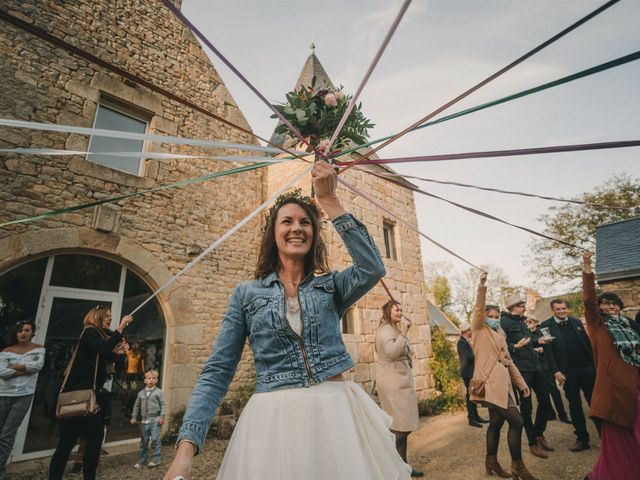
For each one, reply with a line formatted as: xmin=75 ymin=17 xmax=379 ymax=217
xmin=6 ymin=405 xmax=598 ymax=480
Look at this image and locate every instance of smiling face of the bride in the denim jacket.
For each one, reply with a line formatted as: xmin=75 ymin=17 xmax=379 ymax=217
xmin=274 ymin=203 xmax=313 ymax=260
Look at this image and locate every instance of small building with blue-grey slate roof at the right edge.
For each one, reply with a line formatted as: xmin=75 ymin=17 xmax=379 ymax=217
xmin=595 ymin=217 xmax=640 ymax=318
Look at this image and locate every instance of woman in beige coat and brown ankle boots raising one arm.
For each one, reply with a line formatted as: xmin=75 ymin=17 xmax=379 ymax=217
xmin=469 ymin=272 xmax=535 ymax=480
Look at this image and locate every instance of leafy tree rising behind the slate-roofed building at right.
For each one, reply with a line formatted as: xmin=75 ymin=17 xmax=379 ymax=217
xmin=527 ymin=174 xmax=640 ymax=288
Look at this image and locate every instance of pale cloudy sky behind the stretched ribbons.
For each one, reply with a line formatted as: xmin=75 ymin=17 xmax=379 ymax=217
xmin=182 ymin=0 xmax=640 ymax=293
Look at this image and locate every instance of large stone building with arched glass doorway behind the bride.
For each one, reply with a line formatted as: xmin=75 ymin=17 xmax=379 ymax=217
xmin=0 ymin=0 xmax=432 ymax=461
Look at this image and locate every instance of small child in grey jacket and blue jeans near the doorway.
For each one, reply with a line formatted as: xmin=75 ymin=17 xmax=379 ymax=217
xmin=131 ymin=370 xmax=166 ymax=468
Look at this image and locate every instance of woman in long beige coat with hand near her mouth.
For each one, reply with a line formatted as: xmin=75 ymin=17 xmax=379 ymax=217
xmin=376 ymin=300 xmax=424 ymax=477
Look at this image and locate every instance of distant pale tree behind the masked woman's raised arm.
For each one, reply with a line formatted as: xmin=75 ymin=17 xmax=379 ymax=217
xmin=451 ymin=265 xmax=519 ymax=321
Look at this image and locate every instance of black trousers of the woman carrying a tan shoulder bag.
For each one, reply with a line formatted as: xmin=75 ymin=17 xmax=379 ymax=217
xmin=49 ymin=412 xmax=104 ymax=480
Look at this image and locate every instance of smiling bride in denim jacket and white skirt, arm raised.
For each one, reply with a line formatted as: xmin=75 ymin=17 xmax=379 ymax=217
xmin=164 ymin=161 xmax=411 ymax=480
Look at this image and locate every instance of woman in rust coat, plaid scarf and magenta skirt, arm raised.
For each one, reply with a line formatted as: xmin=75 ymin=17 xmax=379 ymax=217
xmin=582 ymin=251 xmax=640 ymax=480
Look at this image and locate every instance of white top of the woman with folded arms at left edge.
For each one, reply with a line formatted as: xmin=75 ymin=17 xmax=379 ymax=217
xmin=0 ymin=347 xmax=45 ymax=397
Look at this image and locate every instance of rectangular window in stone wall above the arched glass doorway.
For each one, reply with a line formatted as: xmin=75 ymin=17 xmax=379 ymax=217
xmin=87 ymin=95 xmax=151 ymax=175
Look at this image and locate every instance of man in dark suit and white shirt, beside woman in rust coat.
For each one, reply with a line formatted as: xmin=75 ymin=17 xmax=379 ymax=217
xmin=542 ymin=299 xmax=598 ymax=452
